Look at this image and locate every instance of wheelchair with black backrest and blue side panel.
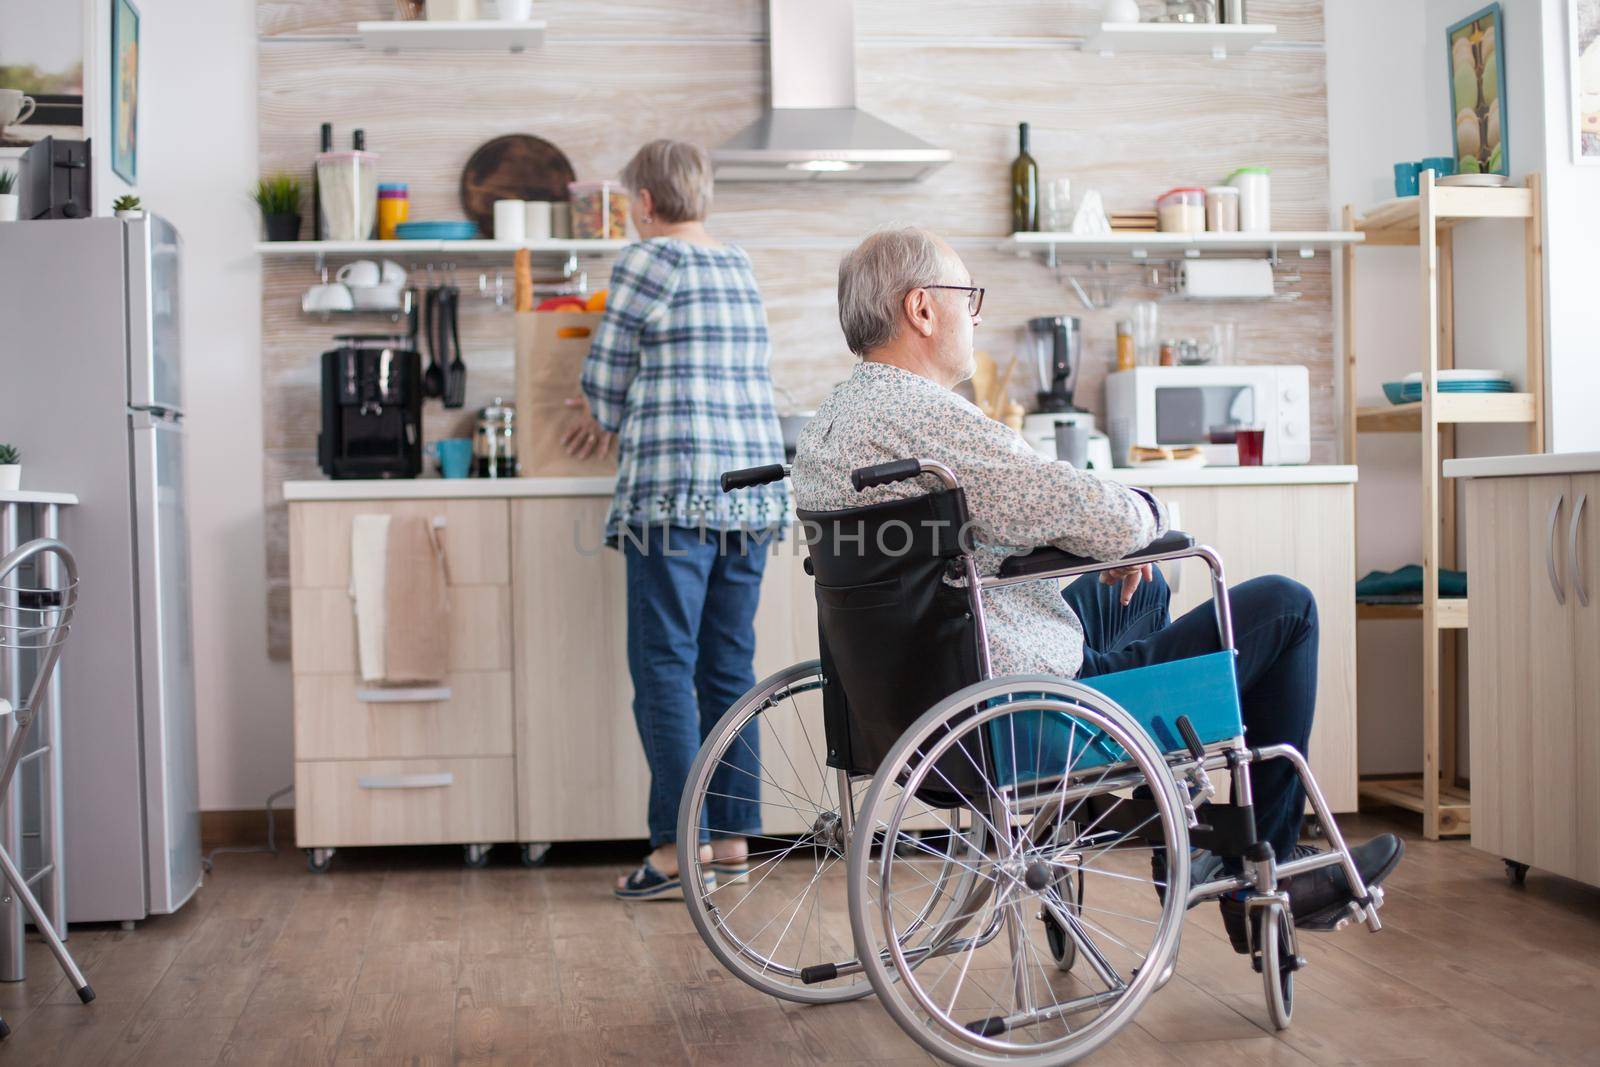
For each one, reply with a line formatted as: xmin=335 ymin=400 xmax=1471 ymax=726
xmin=678 ymin=459 xmax=1382 ymax=1065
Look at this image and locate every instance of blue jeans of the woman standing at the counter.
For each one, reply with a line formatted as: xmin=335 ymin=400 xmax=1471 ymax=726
xmin=621 ymin=526 xmax=770 ymax=848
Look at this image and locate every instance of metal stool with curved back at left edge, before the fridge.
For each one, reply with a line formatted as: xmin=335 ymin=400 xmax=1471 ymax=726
xmin=0 ymin=537 xmax=94 ymax=1037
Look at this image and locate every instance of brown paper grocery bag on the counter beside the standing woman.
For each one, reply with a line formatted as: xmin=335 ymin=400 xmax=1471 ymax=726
xmin=517 ymin=312 xmax=616 ymax=478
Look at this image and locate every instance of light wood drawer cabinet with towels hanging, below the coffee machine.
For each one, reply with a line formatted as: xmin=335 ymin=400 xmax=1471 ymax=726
xmin=290 ymin=499 xmax=517 ymax=848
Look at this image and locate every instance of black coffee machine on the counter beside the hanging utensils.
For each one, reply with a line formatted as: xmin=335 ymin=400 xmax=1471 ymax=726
xmin=317 ymin=334 xmax=422 ymax=478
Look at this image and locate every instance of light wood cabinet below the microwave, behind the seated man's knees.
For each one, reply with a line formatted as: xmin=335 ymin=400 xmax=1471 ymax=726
xmin=1152 ymin=485 xmax=1357 ymax=811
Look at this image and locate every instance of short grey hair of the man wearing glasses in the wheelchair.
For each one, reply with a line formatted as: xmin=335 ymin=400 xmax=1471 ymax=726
xmin=838 ymin=226 xmax=946 ymax=357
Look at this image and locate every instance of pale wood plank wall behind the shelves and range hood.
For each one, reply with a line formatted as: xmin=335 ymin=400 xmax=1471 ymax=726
xmin=258 ymin=0 xmax=1336 ymax=656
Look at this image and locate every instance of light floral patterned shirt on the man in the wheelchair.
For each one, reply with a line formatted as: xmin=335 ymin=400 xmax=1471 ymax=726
xmin=792 ymin=362 xmax=1168 ymax=678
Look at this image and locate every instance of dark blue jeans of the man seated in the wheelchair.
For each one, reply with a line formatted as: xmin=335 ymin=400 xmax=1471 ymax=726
xmin=1061 ymin=569 xmax=1317 ymax=857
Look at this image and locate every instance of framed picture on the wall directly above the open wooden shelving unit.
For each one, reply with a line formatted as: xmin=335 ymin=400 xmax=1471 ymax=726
xmin=1445 ymin=3 xmax=1510 ymax=174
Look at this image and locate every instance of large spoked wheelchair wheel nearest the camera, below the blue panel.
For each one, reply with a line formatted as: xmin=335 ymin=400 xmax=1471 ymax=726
xmin=850 ymin=675 xmax=1189 ymax=1067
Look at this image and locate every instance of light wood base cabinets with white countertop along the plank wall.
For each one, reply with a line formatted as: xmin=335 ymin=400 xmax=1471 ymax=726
xmin=283 ymin=466 xmax=1357 ymax=861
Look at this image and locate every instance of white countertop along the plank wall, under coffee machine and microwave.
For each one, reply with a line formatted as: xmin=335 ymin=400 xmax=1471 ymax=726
xmin=283 ymin=466 xmax=1357 ymax=501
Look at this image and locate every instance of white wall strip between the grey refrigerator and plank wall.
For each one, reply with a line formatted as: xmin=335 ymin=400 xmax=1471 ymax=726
xmin=131 ymin=0 xmax=288 ymax=809
